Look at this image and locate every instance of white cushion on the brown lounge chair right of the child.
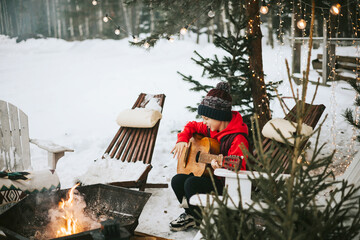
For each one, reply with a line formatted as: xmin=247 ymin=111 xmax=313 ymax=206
xmin=261 ymin=118 xmax=313 ymax=145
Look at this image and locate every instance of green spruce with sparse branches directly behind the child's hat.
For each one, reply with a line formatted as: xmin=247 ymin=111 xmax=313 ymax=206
xmin=178 ymin=1 xmax=281 ymax=125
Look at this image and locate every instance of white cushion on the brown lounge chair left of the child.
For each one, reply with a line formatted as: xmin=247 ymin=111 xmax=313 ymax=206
xmin=116 ymin=108 xmax=162 ymax=128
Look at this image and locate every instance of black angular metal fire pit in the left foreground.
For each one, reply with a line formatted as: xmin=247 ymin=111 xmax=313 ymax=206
xmin=0 ymin=184 xmax=151 ymax=239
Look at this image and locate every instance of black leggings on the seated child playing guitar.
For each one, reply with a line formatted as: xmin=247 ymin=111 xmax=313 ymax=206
xmin=171 ymin=173 xmax=223 ymax=219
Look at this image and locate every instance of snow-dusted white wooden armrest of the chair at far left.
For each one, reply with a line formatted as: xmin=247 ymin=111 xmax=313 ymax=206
xmin=30 ymin=139 xmax=74 ymax=172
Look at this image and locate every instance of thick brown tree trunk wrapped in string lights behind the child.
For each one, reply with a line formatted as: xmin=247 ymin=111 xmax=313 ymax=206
xmin=246 ymin=0 xmax=271 ymax=129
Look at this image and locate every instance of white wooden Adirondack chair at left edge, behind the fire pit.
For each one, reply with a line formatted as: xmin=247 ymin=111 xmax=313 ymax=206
xmin=0 ymin=100 xmax=74 ymax=205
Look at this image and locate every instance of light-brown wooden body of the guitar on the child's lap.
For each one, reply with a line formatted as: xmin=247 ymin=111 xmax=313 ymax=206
xmin=177 ymin=134 xmax=220 ymax=177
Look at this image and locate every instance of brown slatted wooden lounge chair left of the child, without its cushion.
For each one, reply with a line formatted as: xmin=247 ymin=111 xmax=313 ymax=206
xmin=104 ymin=93 xmax=168 ymax=191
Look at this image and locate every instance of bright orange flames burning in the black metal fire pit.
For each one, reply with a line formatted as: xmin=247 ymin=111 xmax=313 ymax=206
xmin=56 ymin=183 xmax=80 ymax=237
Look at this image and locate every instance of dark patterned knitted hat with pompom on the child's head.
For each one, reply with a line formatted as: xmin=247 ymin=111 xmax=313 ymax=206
xmin=198 ymin=82 xmax=232 ymax=121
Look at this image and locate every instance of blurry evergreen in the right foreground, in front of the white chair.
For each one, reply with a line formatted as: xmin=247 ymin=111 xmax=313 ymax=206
xmin=200 ymin=0 xmax=360 ymax=240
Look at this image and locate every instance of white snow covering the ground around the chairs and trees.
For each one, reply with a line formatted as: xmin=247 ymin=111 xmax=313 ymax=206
xmin=0 ymin=30 xmax=359 ymax=239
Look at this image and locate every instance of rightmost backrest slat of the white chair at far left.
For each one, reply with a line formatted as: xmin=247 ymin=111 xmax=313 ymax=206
xmin=19 ymin=109 xmax=31 ymax=170
